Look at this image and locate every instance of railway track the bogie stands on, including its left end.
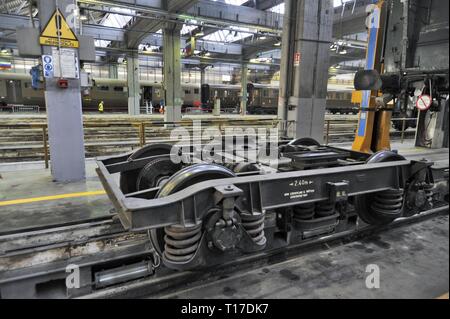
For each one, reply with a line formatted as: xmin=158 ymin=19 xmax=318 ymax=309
xmin=0 ymin=205 xmax=449 ymax=299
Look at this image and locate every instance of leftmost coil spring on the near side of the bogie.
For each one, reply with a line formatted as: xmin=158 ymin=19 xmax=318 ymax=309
xmin=164 ymin=223 xmax=202 ymax=262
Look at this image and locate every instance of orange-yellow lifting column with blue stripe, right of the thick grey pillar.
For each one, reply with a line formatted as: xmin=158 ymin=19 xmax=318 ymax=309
xmin=352 ymin=1 xmax=392 ymax=153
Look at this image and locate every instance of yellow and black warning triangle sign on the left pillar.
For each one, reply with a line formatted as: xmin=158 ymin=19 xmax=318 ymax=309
xmin=39 ymin=9 xmax=80 ymax=48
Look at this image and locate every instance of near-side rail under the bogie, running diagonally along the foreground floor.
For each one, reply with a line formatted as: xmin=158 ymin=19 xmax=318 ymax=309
xmin=81 ymin=205 xmax=449 ymax=299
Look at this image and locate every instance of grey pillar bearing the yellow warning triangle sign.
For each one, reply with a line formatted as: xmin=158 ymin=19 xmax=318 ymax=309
xmin=38 ymin=0 xmax=85 ymax=182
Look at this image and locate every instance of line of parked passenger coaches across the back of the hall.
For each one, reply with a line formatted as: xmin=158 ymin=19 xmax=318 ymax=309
xmin=0 ymin=72 xmax=357 ymax=115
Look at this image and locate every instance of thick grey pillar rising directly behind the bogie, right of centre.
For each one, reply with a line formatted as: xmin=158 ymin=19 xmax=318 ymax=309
xmin=278 ymin=0 xmax=333 ymax=142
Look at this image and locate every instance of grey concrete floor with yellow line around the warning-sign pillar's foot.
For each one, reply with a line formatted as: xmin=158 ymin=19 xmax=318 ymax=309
xmin=0 ymin=161 xmax=112 ymax=234
